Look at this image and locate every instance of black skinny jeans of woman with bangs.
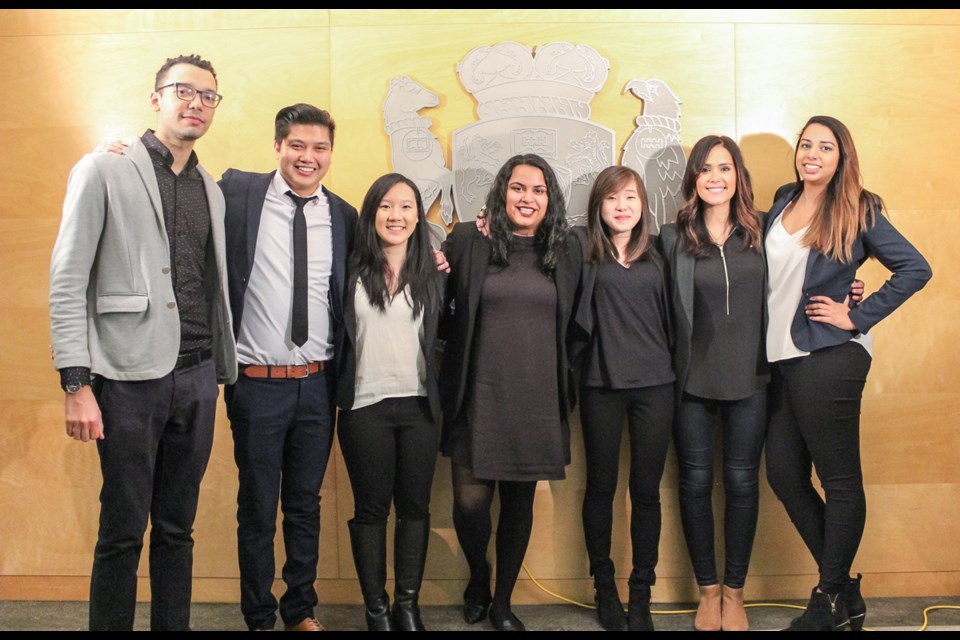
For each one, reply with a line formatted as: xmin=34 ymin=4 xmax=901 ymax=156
xmin=580 ymin=383 xmax=674 ymax=585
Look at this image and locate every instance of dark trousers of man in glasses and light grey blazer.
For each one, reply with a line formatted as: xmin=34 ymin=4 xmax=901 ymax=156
xmin=90 ymin=360 xmax=220 ymax=631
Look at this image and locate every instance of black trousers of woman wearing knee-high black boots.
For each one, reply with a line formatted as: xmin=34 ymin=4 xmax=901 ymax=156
xmin=337 ymin=397 xmax=440 ymax=524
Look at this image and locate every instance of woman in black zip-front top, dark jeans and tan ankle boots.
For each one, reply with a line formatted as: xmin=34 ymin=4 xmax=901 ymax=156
xmin=660 ymin=136 xmax=769 ymax=631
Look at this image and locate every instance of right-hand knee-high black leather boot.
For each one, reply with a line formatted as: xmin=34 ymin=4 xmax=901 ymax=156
xmin=393 ymin=518 xmax=430 ymax=631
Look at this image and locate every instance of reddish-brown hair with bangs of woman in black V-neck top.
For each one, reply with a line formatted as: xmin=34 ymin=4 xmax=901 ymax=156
xmin=587 ymin=165 xmax=650 ymax=264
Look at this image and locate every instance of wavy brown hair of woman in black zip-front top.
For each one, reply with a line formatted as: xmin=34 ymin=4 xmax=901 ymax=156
xmin=677 ymin=136 xmax=763 ymax=258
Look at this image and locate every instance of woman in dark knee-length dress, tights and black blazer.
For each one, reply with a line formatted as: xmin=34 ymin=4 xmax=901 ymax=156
xmin=441 ymin=154 xmax=581 ymax=630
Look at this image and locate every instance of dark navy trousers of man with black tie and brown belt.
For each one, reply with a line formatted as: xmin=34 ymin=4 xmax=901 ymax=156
xmin=224 ymin=372 xmax=333 ymax=629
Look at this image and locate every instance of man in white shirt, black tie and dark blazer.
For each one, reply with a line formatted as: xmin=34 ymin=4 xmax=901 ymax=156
xmin=220 ymin=104 xmax=357 ymax=631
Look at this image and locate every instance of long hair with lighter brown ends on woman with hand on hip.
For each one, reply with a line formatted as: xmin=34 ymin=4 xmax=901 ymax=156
xmin=793 ymin=116 xmax=884 ymax=262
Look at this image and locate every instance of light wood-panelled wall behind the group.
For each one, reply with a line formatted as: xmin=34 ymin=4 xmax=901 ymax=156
xmin=0 ymin=10 xmax=960 ymax=603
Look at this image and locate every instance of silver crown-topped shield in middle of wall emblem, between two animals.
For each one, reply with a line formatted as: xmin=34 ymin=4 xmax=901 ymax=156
xmin=451 ymin=42 xmax=615 ymax=224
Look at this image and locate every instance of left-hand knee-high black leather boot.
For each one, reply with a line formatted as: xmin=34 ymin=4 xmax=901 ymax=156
xmin=347 ymin=520 xmax=397 ymax=631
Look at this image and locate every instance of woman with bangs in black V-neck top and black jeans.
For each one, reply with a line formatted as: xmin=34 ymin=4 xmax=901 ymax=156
xmin=576 ymin=166 xmax=674 ymax=631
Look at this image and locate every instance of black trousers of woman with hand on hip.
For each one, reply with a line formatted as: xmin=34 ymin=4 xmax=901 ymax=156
xmin=767 ymin=342 xmax=871 ymax=593
